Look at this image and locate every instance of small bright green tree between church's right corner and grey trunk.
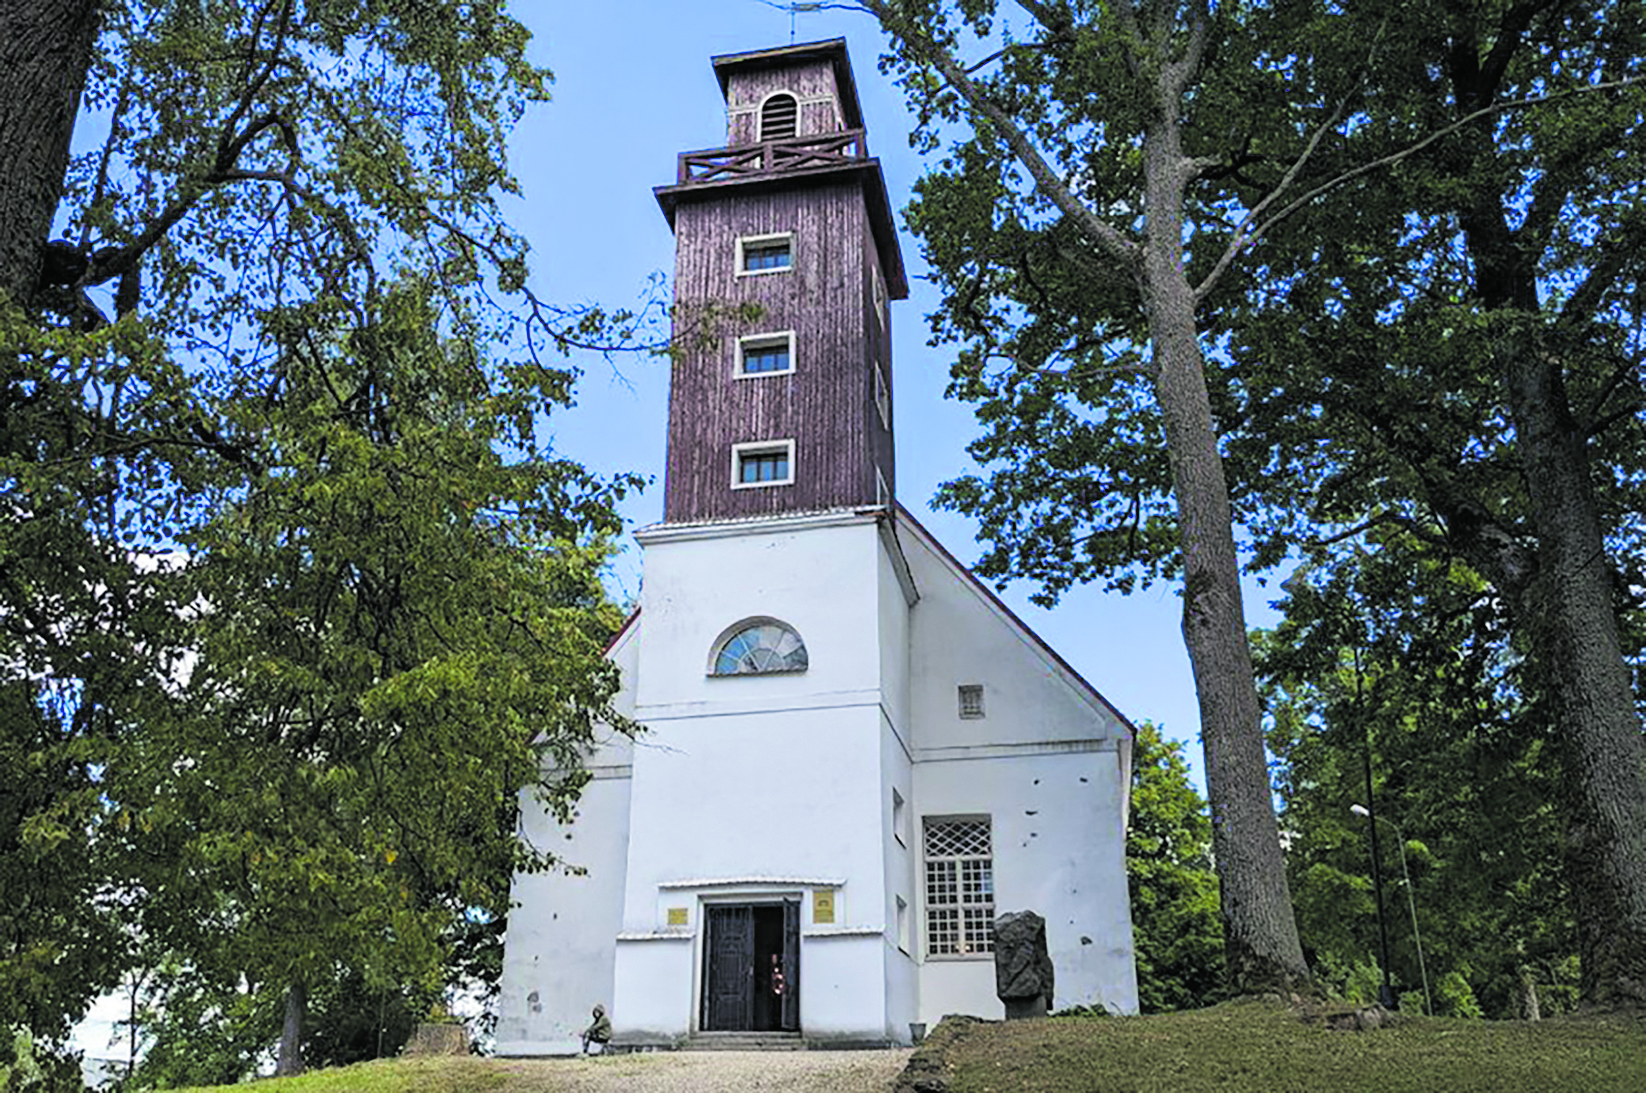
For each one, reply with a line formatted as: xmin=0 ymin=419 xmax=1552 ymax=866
xmin=1126 ymin=721 xmax=1223 ymax=1014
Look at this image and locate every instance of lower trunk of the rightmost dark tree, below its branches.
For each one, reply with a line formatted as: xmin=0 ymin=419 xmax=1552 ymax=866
xmin=1504 ymin=336 xmax=1646 ymax=1007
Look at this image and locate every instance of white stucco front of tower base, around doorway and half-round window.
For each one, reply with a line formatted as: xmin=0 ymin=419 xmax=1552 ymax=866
xmin=612 ymin=517 xmax=907 ymax=1040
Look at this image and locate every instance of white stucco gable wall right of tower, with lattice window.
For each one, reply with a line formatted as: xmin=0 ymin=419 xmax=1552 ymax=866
xmin=899 ymin=513 xmax=1137 ymax=1024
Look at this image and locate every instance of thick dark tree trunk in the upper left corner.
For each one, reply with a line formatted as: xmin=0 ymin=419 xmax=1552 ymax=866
xmin=0 ymin=0 xmax=99 ymax=303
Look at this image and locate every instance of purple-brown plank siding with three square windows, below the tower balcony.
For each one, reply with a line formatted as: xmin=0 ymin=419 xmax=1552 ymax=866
xmin=663 ymin=181 xmax=894 ymax=523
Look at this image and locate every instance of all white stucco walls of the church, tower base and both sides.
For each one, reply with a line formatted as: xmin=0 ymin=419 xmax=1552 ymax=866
xmin=499 ymin=514 xmax=1137 ymax=1053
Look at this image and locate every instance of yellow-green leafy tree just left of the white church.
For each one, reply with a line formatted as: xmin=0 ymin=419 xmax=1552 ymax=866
xmin=105 ymin=286 xmax=627 ymax=1062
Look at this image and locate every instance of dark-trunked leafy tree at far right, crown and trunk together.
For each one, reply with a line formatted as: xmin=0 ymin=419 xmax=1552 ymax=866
xmin=1218 ymin=3 xmax=1646 ymax=1006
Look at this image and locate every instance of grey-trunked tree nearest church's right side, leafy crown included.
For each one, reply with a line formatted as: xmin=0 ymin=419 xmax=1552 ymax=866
xmin=863 ymin=0 xmax=1337 ymax=991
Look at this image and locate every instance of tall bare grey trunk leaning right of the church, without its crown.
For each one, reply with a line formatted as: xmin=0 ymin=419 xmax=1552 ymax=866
xmin=1142 ymin=117 xmax=1309 ymax=993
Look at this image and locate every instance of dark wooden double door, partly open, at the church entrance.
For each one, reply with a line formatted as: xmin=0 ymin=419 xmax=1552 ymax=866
xmin=701 ymin=900 xmax=800 ymax=1032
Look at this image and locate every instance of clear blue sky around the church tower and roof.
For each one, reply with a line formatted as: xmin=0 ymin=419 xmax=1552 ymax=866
xmin=510 ymin=0 xmax=1274 ymax=785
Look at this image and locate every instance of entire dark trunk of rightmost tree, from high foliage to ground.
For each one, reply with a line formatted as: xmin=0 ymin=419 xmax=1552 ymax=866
xmin=1452 ymin=17 xmax=1646 ymax=1007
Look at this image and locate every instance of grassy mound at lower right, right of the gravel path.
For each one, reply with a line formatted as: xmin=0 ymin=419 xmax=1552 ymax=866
xmin=921 ymin=1002 xmax=1646 ymax=1093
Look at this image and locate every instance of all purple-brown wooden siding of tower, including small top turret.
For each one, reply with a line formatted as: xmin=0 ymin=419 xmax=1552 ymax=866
xmin=657 ymin=40 xmax=909 ymax=523
